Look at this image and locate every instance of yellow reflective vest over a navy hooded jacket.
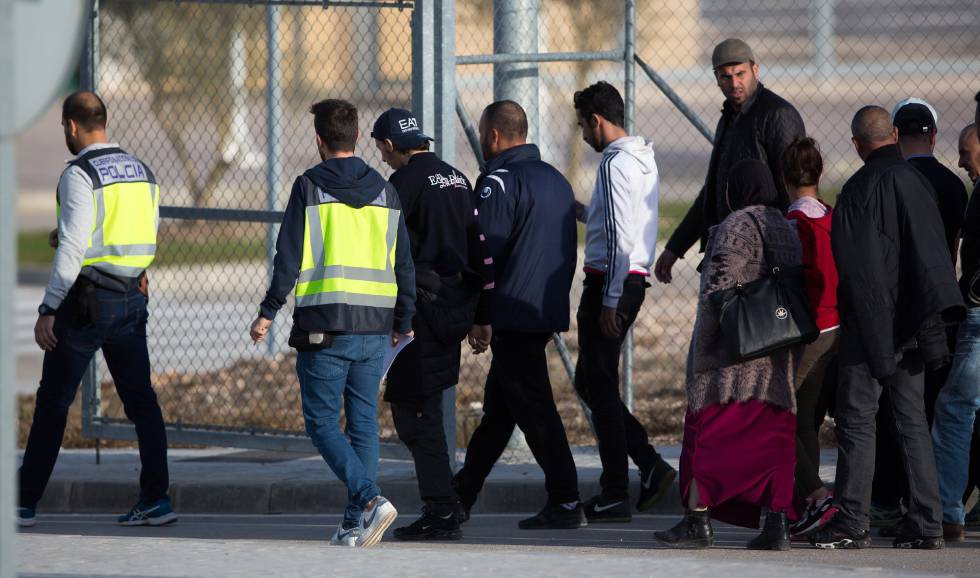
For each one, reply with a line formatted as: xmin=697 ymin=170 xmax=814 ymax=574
xmin=296 ymin=185 xmax=401 ymax=309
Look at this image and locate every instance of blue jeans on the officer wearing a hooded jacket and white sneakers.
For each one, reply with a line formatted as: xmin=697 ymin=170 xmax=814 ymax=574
xmin=296 ymin=335 xmax=390 ymax=522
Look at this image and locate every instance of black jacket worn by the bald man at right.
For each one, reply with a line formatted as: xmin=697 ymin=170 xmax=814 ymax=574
xmin=831 ymin=145 xmax=965 ymax=379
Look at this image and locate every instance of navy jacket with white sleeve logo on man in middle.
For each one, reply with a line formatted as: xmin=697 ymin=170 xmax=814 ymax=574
xmin=475 ymin=144 xmax=578 ymax=333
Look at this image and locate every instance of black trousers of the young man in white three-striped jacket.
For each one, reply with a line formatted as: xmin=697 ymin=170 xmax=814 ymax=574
xmin=575 ymin=275 xmax=660 ymax=501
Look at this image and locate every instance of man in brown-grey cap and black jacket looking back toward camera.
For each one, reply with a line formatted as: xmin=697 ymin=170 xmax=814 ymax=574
xmin=654 ymin=38 xmax=806 ymax=283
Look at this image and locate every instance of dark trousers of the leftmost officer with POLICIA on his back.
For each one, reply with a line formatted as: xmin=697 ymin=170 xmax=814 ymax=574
xmin=20 ymin=288 xmax=170 ymax=508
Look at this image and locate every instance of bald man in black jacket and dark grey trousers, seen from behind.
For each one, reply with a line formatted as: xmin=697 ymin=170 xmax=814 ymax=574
xmin=810 ymin=106 xmax=963 ymax=549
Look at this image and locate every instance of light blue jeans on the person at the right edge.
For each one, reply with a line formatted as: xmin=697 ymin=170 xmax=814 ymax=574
xmin=932 ymin=307 xmax=980 ymax=524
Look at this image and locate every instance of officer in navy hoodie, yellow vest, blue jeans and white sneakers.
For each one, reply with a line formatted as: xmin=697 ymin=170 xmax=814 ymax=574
xmin=251 ymin=100 xmax=415 ymax=547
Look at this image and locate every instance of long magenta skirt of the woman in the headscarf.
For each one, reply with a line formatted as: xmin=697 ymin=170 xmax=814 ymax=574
xmin=680 ymin=400 xmax=796 ymax=528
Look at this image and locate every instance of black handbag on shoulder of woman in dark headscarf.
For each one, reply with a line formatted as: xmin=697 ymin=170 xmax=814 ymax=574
xmin=708 ymin=213 xmax=820 ymax=361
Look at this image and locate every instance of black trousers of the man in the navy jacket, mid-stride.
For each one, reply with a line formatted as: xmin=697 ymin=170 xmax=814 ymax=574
xmin=456 ymin=332 xmax=579 ymax=508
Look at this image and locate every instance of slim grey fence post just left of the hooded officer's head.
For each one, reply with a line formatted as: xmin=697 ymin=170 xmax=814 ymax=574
xmin=265 ymin=5 xmax=283 ymax=355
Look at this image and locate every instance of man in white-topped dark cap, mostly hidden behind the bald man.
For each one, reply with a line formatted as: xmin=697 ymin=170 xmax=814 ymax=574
xmin=871 ymin=98 xmax=967 ymax=524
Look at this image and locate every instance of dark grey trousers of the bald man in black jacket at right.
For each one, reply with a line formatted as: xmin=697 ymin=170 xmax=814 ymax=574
xmin=834 ymin=327 xmax=943 ymax=536
